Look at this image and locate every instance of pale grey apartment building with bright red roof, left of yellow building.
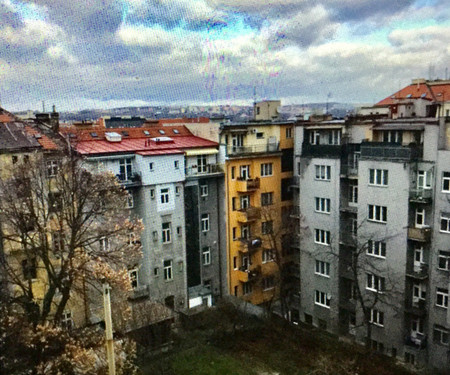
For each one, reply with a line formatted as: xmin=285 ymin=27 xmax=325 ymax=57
xmin=68 ymin=125 xmax=224 ymax=311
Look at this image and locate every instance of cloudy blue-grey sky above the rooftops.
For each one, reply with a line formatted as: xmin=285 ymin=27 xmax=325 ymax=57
xmin=0 ymin=0 xmax=450 ymax=111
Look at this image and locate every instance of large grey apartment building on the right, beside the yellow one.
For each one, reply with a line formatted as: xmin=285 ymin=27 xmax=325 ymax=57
xmin=295 ymin=80 xmax=450 ymax=370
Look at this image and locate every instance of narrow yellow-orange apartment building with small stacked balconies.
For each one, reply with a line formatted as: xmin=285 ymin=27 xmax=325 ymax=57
xmin=220 ymin=104 xmax=298 ymax=312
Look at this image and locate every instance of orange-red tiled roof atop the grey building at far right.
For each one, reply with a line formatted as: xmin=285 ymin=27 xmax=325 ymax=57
xmin=375 ymin=83 xmax=450 ymax=106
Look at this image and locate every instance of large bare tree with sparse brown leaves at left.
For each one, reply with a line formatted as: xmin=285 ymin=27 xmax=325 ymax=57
xmin=0 ymin=150 xmax=141 ymax=373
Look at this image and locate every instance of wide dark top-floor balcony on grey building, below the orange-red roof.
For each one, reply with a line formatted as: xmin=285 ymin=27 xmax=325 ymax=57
xmin=361 ymin=142 xmax=422 ymax=161
